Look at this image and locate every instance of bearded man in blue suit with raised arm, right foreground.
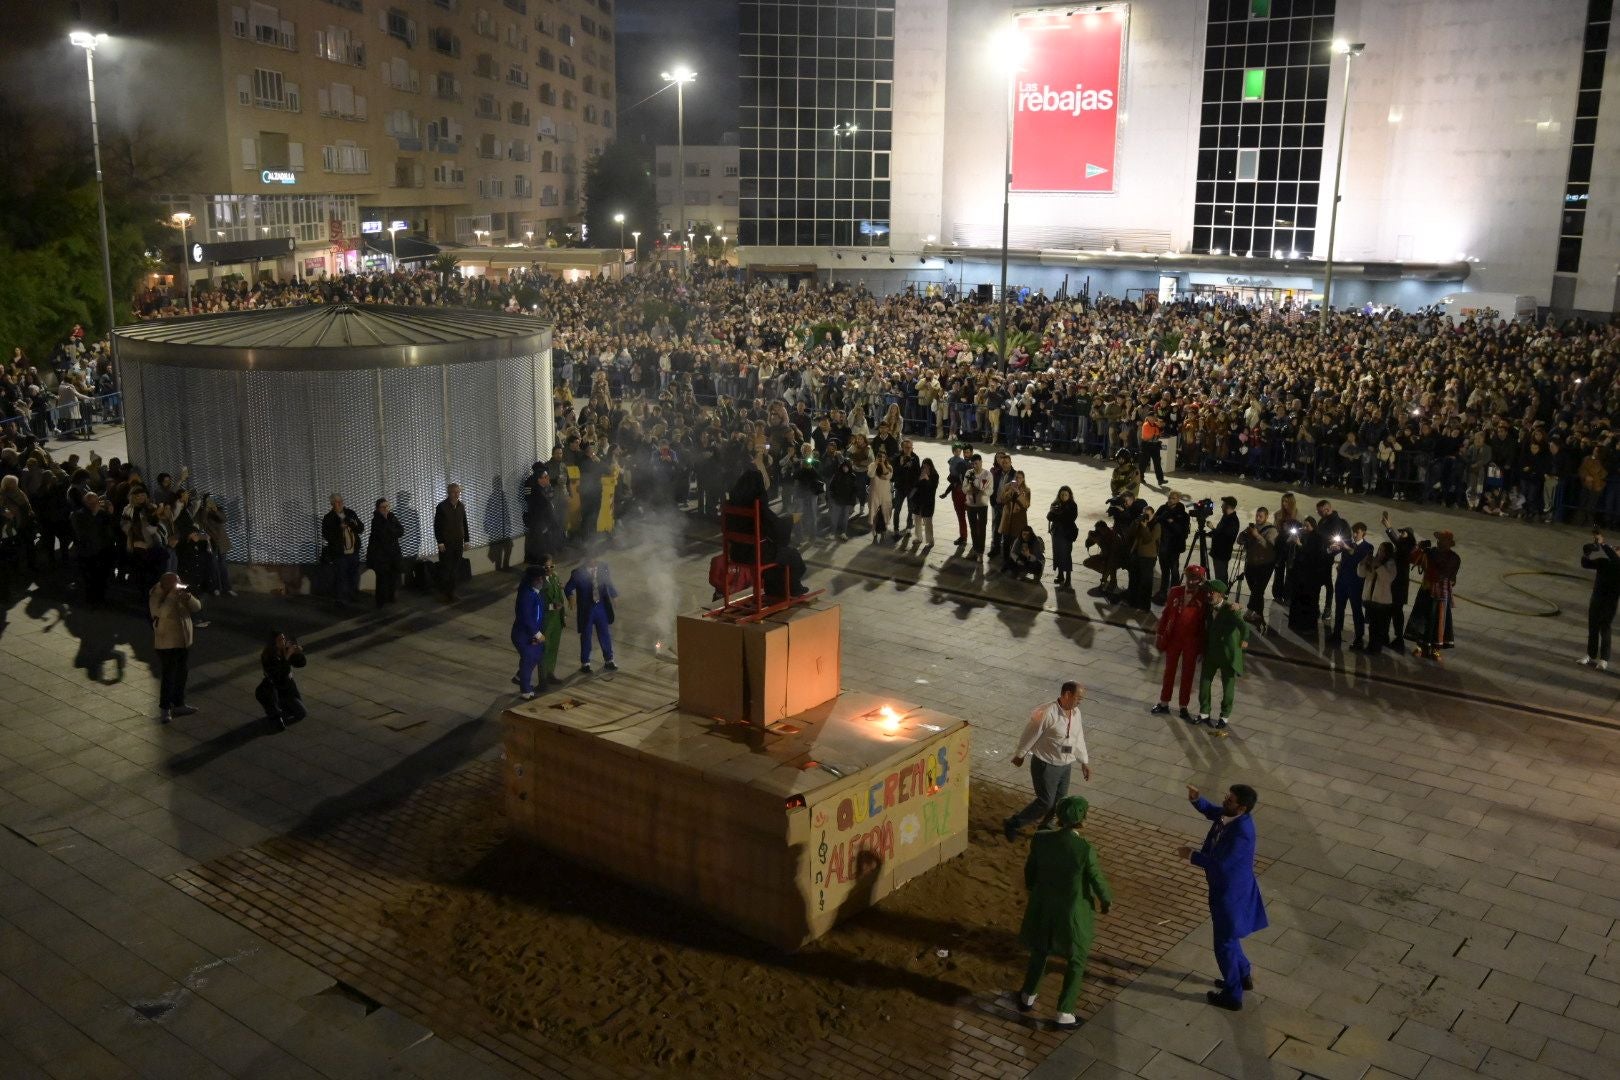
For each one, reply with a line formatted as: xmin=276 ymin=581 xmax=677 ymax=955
xmin=1178 ymin=784 xmax=1267 ymax=1010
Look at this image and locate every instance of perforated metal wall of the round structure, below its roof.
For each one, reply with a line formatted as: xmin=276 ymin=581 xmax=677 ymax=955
xmin=123 ymin=341 xmax=552 ymax=563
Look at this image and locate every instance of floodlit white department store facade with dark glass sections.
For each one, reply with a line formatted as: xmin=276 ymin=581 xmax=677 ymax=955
xmin=739 ymin=0 xmax=1620 ymax=313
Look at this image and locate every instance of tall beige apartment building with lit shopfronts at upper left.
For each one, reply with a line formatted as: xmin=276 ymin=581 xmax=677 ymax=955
xmin=0 ymin=0 xmax=616 ymax=277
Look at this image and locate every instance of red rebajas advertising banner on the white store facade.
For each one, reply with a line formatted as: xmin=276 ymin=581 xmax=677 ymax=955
xmin=1013 ymin=6 xmax=1126 ymax=191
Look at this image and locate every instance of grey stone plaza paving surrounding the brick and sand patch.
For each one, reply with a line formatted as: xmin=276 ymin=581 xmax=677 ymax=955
xmin=0 ymin=427 xmax=1620 ymax=1080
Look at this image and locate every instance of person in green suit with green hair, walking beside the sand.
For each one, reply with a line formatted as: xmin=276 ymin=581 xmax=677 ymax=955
xmin=1017 ymin=795 xmax=1113 ymax=1028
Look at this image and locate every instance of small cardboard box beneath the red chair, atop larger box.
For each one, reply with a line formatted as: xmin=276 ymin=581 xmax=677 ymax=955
xmin=676 ymin=604 xmax=842 ymax=725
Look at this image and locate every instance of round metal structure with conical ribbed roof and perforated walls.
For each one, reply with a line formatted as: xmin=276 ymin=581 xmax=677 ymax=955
xmin=117 ymin=304 xmax=554 ymax=565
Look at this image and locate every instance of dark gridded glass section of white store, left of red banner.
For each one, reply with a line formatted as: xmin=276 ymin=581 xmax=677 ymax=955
xmin=738 ymin=0 xmax=894 ymax=246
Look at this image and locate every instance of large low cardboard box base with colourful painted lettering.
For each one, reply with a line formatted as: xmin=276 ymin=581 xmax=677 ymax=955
xmin=504 ymin=683 xmax=970 ymax=949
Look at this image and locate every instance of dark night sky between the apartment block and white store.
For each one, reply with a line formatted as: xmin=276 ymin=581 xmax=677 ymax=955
xmin=617 ymin=0 xmax=740 ymax=146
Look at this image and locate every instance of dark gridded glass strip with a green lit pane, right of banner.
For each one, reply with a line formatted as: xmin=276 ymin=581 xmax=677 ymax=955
xmin=1192 ymin=0 xmax=1335 ymax=257
